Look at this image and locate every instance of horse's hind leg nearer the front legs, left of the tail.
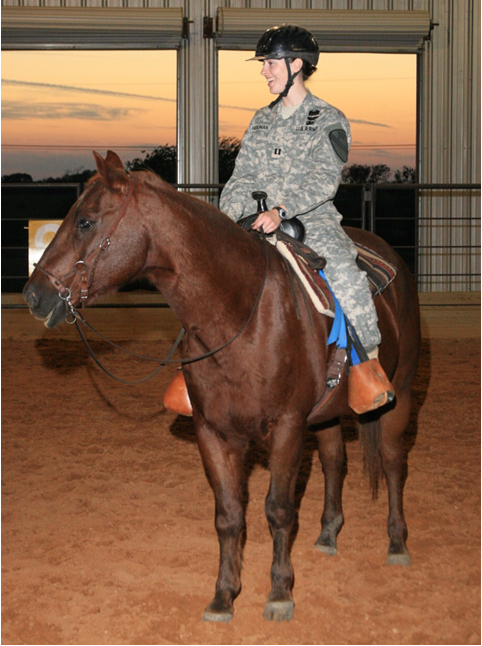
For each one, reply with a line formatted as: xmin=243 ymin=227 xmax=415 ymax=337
xmin=315 ymin=424 xmax=346 ymax=554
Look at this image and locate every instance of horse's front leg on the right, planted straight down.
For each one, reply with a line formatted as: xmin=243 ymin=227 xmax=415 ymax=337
xmin=263 ymin=422 xmax=305 ymax=621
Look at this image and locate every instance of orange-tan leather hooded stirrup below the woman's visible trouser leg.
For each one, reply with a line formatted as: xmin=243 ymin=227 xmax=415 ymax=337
xmin=348 ymin=347 xmax=395 ymax=415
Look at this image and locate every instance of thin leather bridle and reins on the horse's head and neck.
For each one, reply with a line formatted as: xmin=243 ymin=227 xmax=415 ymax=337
xmin=36 ymin=182 xmax=269 ymax=385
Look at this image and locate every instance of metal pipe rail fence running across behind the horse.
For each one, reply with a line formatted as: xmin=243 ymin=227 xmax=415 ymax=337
xmin=2 ymin=183 xmax=481 ymax=307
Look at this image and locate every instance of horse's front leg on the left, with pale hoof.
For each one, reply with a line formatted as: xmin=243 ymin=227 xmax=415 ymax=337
xmin=196 ymin=422 xmax=246 ymax=622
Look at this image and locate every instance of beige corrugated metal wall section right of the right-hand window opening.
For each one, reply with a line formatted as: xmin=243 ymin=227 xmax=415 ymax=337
xmin=420 ymin=0 xmax=480 ymax=291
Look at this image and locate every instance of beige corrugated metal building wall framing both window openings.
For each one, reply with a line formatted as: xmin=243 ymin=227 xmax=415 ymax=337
xmin=2 ymin=0 xmax=481 ymax=291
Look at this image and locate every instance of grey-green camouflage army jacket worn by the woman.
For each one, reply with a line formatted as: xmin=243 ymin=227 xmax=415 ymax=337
xmin=220 ymin=91 xmax=351 ymax=237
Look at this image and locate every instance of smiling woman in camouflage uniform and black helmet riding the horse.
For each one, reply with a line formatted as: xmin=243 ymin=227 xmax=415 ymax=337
xmin=220 ymin=25 xmax=393 ymax=412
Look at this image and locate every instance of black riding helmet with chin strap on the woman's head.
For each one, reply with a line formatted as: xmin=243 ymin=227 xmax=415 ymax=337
xmin=248 ymin=25 xmax=320 ymax=108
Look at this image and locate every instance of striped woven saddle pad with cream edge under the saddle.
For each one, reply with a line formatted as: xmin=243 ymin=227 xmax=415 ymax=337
xmin=273 ymin=232 xmax=397 ymax=317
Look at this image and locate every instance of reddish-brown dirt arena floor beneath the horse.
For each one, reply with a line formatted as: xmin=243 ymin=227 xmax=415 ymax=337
xmin=2 ymin=314 xmax=480 ymax=644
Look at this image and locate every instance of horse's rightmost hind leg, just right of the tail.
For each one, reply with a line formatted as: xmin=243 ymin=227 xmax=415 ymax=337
xmin=380 ymin=391 xmax=411 ymax=565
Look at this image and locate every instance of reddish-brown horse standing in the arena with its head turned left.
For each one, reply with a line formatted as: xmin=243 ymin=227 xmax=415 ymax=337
xmin=24 ymin=152 xmax=420 ymax=621
